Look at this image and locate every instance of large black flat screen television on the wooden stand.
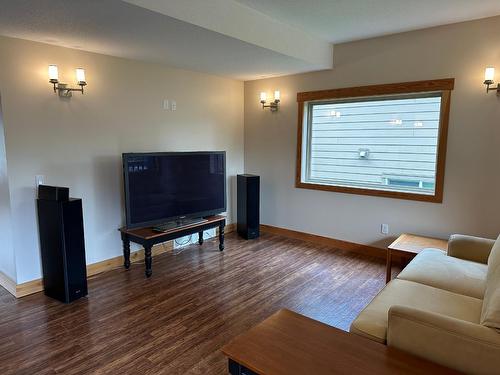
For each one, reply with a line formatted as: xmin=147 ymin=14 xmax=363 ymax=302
xmin=122 ymin=151 xmax=226 ymax=228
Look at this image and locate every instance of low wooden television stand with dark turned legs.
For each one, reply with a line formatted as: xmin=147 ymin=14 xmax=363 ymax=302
xmin=119 ymin=215 xmax=226 ymax=277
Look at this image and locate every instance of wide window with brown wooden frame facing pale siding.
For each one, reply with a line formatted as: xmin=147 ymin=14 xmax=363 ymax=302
xmin=296 ymin=79 xmax=454 ymax=202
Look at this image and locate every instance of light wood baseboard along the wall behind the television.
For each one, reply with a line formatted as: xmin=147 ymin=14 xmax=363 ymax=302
xmin=13 ymin=223 xmax=236 ymax=298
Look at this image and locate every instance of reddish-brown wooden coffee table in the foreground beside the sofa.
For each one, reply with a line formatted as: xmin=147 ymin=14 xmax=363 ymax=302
xmin=222 ymin=310 xmax=455 ymax=375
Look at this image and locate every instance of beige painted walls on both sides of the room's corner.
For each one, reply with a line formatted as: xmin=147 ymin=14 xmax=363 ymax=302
xmin=0 ymin=17 xmax=500 ymax=283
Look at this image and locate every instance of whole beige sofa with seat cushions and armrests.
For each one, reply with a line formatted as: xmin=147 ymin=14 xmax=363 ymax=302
xmin=350 ymin=235 xmax=500 ymax=374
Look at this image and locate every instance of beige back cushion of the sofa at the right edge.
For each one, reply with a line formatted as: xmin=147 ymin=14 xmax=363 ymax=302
xmin=481 ymin=236 xmax=500 ymax=329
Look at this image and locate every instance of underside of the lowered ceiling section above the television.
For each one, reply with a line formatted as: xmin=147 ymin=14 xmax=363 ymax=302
xmin=0 ymin=0 xmax=332 ymax=80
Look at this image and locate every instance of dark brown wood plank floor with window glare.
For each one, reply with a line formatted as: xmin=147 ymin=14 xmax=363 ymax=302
xmin=0 ymin=233 xmax=396 ymax=375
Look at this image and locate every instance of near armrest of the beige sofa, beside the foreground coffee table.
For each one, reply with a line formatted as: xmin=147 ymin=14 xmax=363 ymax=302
xmin=387 ymin=305 xmax=500 ymax=374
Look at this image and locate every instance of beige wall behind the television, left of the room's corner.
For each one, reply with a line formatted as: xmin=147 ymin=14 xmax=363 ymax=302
xmin=0 ymin=38 xmax=243 ymax=283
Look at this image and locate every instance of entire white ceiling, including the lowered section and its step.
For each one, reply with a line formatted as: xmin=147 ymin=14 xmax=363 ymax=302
xmin=0 ymin=0 xmax=500 ymax=80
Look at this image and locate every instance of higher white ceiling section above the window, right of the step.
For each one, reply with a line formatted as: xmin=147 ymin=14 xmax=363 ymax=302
xmin=235 ymin=0 xmax=500 ymax=43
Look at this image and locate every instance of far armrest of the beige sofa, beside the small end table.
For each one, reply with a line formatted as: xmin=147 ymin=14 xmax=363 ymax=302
xmin=448 ymin=234 xmax=495 ymax=264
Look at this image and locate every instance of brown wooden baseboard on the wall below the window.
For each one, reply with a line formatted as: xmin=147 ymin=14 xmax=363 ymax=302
xmin=260 ymin=224 xmax=387 ymax=259
